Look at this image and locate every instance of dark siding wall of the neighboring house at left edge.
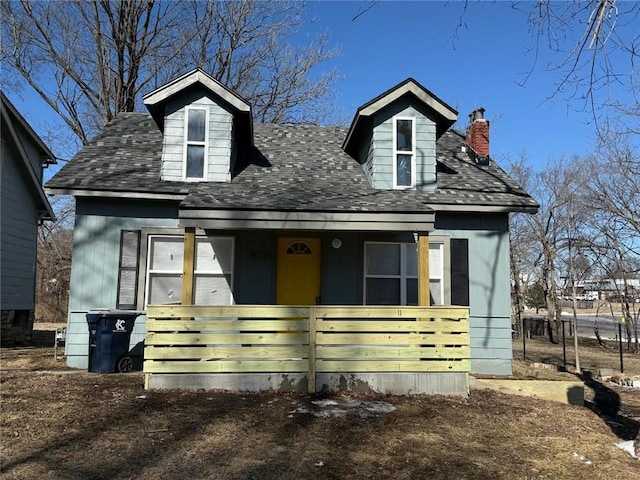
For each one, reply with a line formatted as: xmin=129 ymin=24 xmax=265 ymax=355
xmin=0 ymin=140 xmax=38 ymax=310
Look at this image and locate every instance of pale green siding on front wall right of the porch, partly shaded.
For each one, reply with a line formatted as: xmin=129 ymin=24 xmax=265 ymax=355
xmin=432 ymin=213 xmax=512 ymax=375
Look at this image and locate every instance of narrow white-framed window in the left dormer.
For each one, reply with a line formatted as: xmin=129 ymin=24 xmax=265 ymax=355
xmin=184 ymin=108 xmax=209 ymax=180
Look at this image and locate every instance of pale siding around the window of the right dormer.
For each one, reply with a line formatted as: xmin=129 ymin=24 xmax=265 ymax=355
xmin=371 ymin=100 xmax=436 ymax=191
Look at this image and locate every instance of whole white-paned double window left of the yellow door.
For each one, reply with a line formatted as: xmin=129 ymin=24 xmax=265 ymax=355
xmin=145 ymin=235 xmax=234 ymax=305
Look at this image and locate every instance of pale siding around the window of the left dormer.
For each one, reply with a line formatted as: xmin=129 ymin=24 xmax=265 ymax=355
xmin=161 ymin=91 xmax=233 ymax=182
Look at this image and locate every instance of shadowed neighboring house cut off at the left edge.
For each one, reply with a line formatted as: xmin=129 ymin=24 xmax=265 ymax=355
xmin=0 ymin=92 xmax=56 ymax=345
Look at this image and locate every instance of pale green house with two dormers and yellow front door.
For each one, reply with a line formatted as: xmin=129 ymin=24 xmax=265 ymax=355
xmin=47 ymin=70 xmax=538 ymax=390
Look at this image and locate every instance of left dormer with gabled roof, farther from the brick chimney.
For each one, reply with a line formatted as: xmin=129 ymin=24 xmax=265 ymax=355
xmin=144 ymin=69 xmax=253 ymax=182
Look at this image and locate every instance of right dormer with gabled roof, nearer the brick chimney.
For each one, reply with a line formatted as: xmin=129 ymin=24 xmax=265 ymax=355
xmin=342 ymin=78 xmax=458 ymax=191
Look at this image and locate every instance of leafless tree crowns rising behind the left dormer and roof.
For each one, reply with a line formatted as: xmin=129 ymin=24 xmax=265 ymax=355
xmin=0 ymin=0 xmax=337 ymax=144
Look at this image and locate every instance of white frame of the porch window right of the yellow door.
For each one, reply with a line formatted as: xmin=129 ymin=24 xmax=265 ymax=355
xmin=362 ymin=235 xmax=451 ymax=305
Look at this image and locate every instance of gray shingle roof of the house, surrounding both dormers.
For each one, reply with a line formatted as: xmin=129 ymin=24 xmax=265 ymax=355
xmin=46 ymin=113 xmax=537 ymax=212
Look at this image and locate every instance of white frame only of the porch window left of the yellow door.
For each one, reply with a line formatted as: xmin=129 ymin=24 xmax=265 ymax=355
xmin=141 ymin=233 xmax=235 ymax=308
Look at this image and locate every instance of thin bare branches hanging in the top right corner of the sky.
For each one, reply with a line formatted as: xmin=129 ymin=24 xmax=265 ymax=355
xmin=514 ymin=0 xmax=640 ymax=133
